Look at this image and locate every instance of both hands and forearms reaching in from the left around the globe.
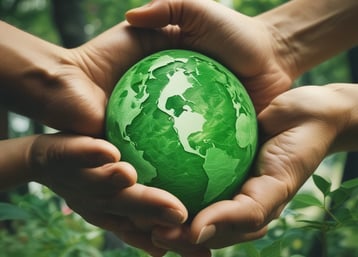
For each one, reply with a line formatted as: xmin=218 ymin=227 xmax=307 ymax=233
xmin=0 ymin=21 xmax=187 ymax=256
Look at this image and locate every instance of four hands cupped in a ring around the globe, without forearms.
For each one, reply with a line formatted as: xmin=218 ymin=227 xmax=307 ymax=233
xmin=21 ymin=0 xmax=356 ymax=257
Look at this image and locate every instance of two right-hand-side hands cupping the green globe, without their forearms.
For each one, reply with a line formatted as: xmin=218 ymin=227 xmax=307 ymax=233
xmin=126 ymin=0 xmax=357 ymax=254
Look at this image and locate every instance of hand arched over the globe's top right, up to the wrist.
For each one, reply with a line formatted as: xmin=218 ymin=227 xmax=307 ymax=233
xmin=126 ymin=0 xmax=294 ymax=112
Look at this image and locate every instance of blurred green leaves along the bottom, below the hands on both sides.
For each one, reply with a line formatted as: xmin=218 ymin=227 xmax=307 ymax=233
xmin=0 ymin=175 xmax=358 ymax=257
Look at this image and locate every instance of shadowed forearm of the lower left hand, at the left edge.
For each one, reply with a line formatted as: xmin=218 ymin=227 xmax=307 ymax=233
xmin=0 ymin=136 xmax=35 ymax=191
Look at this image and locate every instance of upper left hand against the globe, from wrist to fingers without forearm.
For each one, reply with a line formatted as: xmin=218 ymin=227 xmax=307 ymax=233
xmin=57 ymin=22 xmax=173 ymax=135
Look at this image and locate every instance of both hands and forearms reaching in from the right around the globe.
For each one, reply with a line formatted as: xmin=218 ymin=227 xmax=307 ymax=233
xmin=127 ymin=0 xmax=358 ymax=254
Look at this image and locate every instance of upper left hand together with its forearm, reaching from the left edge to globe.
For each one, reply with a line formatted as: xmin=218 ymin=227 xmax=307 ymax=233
xmin=0 ymin=21 xmax=169 ymax=136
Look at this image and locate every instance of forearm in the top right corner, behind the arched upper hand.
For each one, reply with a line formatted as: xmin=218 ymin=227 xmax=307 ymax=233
xmin=257 ymin=0 xmax=358 ymax=78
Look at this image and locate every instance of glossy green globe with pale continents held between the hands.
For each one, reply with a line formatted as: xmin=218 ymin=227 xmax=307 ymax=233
xmin=106 ymin=50 xmax=257 ymax=215
